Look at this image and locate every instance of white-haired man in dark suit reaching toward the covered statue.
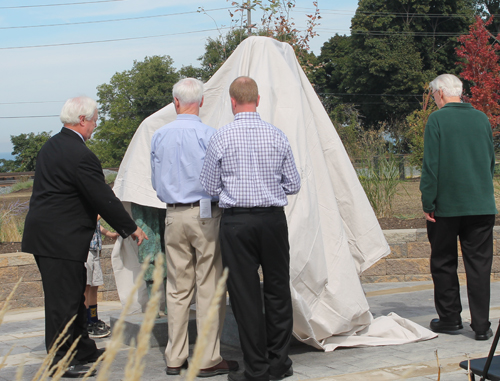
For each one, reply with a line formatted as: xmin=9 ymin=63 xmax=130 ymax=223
xmin=22 ymin=97 xmax=147 ymax=377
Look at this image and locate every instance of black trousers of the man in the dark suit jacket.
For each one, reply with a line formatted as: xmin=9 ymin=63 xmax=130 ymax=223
xmin=35 ymin=255 xmax=97 ymax=364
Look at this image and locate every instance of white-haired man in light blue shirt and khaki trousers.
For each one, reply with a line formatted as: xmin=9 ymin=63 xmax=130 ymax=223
xmin=151 ymin=78 xmax=238 ymax=377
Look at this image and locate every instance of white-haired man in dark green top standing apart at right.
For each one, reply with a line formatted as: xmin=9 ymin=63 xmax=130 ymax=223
xmin=420 ymin=74 xmax=497 ymax=340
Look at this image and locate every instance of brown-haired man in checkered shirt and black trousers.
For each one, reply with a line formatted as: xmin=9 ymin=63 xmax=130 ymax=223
xmin=200 ymin=77 xmax=300 ymax=381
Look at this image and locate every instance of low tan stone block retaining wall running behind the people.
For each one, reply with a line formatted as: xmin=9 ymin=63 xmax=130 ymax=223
xmin=0 ymin=226 xmax=500 ymax=308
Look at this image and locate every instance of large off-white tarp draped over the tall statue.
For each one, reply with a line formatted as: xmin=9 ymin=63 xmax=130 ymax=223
xmin=112 ymin=37 xmax=436 ymax=351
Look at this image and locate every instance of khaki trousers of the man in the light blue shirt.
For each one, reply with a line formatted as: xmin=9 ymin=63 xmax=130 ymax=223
xmin=165 ymin=205 xmax=226 ymax=369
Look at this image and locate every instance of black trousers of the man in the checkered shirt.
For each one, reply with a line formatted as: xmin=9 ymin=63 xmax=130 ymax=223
xmin=219 ymin=208 xmax=293 ymax=381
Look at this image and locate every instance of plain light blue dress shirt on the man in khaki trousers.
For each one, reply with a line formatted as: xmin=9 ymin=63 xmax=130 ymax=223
xmin=151 ymin=114 xmax=218 ymax=204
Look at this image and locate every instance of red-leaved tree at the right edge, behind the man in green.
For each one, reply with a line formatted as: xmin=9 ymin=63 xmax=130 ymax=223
xmin=456 ymin=16 xmax=500 ymax=128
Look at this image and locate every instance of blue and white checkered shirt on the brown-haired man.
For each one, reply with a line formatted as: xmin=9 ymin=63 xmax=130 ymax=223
xmin=200 ymin=112 xmax=300 ymax=208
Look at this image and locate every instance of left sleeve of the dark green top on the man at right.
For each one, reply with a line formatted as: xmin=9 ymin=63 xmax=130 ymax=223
xmin=420 ymin=115 xmax=439 ymax=213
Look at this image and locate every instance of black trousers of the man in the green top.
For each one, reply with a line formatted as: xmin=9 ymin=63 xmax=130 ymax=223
xmin=427 ymin=215 xmax=495 ymax=332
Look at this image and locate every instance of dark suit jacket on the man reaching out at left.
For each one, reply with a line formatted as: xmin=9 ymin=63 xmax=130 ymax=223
xmin=22 ymin=128 xmax=137 ymax=262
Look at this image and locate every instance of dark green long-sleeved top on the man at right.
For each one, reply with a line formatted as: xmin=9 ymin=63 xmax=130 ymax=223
xmin=420 ymin=103 xmax=497 ymax=217
